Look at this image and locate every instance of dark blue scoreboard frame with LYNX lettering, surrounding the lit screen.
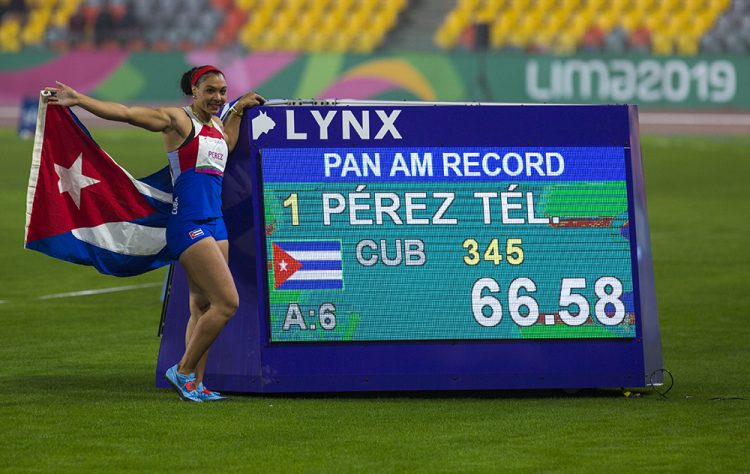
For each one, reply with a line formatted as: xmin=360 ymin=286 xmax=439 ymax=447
xmin=157 ymin=101 xmax=662 ymax=392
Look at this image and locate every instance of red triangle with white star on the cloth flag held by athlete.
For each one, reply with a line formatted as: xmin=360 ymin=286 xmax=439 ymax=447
xmin=26 ymin=104 xmax=158 ymax=242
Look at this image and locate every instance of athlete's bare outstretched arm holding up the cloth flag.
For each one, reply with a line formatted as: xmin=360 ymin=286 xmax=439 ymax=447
xmin=45 ymin=82 xmax=179 ymax=133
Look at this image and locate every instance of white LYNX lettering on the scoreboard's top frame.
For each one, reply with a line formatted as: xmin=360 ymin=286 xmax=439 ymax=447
xmin=284 ymin=110 xmax=401 ymax=140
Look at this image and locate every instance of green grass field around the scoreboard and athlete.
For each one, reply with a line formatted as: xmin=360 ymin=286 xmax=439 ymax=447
xmin=0 ymin=129 xmax=750 ymax=473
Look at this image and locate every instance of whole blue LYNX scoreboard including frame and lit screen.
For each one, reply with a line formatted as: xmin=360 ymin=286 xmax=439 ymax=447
xmin=159 ymin=102 xmax=661 ymax=391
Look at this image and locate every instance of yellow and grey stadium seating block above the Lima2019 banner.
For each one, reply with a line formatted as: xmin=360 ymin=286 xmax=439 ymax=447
xmin=434 ymin=0 xmax=750 ymax=55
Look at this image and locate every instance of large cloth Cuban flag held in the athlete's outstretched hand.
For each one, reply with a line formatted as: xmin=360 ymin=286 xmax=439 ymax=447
xmin=24 ymin=92 xmax=172 ymax=276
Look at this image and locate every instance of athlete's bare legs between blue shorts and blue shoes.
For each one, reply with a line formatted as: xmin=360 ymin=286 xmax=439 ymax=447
xmin=178 ymin=237 xmax=239 ymax=374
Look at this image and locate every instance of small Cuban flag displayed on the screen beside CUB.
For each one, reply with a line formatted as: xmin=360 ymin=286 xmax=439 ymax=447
xmin=272 ymin=240 xmax=344 ymax=290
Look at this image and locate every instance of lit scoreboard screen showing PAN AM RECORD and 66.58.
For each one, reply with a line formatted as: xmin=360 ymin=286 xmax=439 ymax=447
xmin=260 ymin=140 xmax=639 ymax=344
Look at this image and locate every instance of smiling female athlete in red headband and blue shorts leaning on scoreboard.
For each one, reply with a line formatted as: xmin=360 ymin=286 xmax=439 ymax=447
xmin=46 ymin=66 xmax=265 ymax=402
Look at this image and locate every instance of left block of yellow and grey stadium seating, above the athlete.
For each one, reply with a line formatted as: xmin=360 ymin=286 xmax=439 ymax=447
xmin=0 ymin=0 xmax=407 ymax=52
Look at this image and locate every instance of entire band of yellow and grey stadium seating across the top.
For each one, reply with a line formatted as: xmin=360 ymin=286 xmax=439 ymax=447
xmin=0 ymin=0 xmax=750 ymax=55
